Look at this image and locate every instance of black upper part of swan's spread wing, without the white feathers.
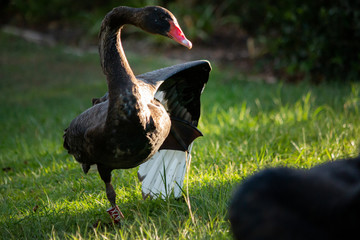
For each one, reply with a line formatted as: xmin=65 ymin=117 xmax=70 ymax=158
xmin=138 ymin=60 xmax=211 ymax=151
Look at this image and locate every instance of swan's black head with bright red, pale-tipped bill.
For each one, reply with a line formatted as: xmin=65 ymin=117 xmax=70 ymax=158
xmin=142 ymin=6 xmax=192 ymax=49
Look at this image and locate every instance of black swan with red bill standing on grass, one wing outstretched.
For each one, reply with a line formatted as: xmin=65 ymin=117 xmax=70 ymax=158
xmin=64 ymin=6 xmax=211 ymax=222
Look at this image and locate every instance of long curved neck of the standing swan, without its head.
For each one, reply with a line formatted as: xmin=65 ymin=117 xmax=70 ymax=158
xmin=99 ymin=7 xmax=143 ymax=125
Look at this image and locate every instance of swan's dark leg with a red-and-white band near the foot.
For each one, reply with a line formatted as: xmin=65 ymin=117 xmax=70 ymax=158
xmin=98 ymin=164 xmax=124 ymax=223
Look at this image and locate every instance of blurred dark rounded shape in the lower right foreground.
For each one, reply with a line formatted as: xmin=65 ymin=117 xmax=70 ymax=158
xmin=229 ymin=157 xmax=360 ymax=240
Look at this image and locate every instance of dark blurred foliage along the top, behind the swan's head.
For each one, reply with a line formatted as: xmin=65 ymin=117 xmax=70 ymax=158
xmin=0 ymin=0 xmax=360 ymax=81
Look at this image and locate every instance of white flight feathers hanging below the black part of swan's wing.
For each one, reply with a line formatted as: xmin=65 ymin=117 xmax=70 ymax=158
xmin=138 ymin=146 xmax=191 ymax=199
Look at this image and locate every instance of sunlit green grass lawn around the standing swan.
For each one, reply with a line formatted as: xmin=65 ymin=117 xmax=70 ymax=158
xmin=0 ymin=30 xmax=360 ymax=239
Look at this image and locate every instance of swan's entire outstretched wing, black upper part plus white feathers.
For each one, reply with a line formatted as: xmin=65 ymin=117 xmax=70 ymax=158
xmin=138 ymin=61 xmax=211 ymax=199
